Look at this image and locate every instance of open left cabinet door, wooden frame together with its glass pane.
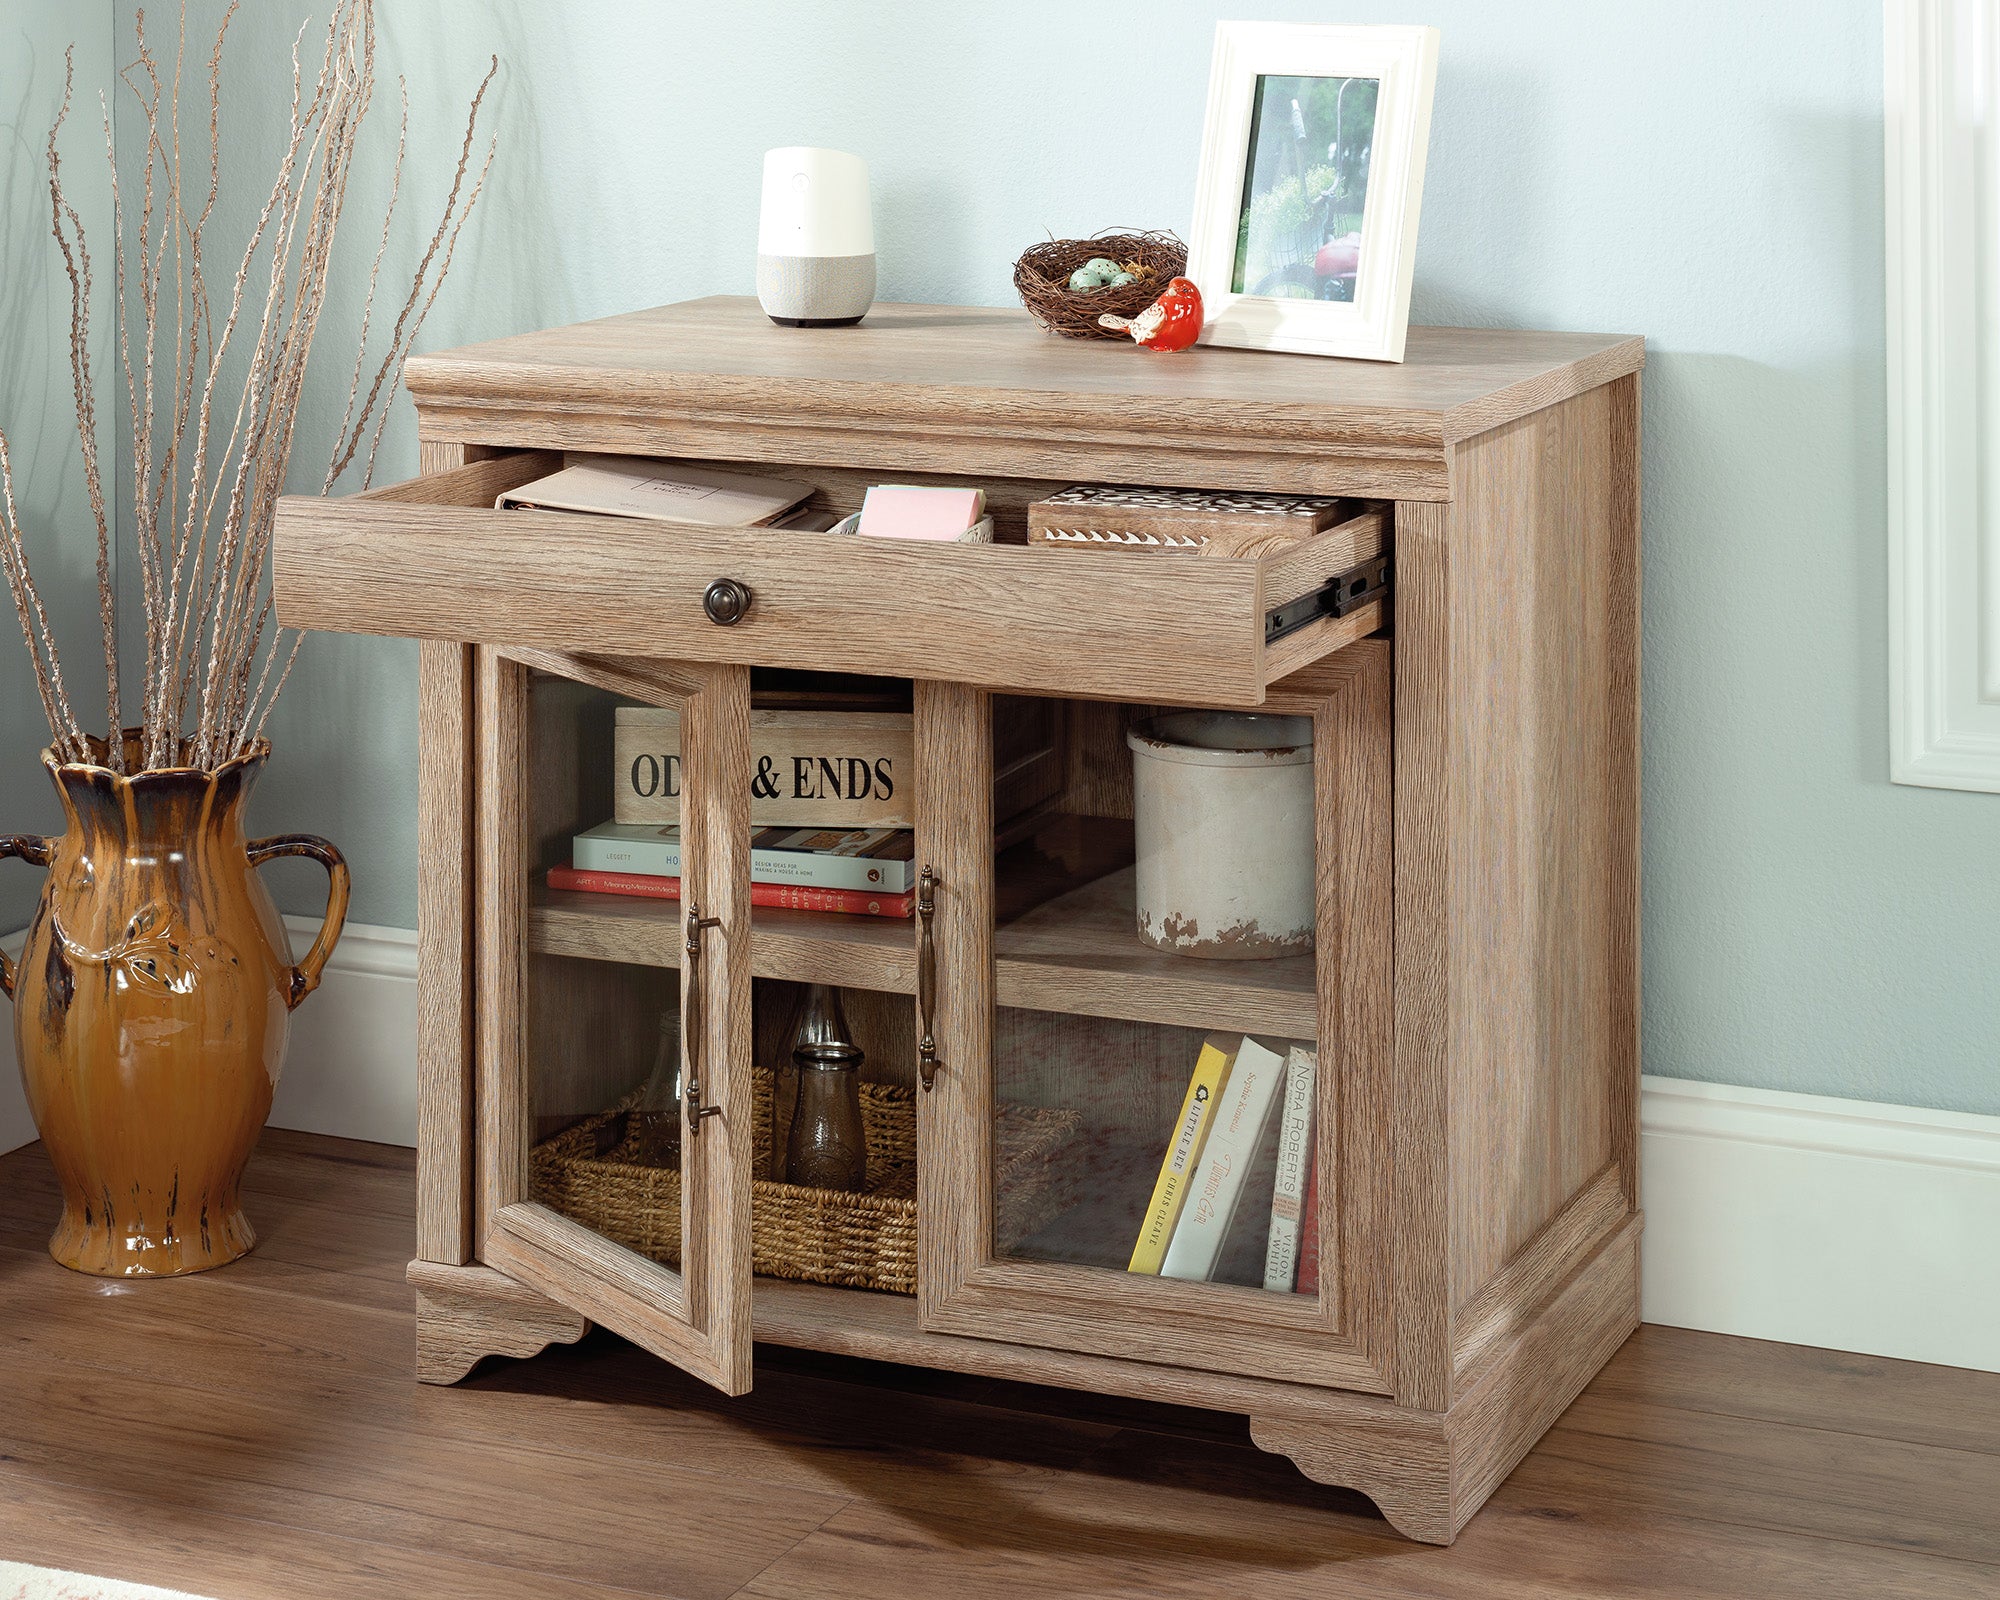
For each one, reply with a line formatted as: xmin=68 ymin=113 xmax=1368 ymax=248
xmin=474 ymin=648 xmax=754 ymax=1394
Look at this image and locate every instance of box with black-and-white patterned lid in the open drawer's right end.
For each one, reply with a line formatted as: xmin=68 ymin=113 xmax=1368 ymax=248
xmin=1028 ymin=484 xmax=1352 ymax=554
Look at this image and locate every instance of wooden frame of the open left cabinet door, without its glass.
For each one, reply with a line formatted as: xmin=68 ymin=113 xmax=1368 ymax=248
xmin=474 ymin=646 xmax=752 ymax=1394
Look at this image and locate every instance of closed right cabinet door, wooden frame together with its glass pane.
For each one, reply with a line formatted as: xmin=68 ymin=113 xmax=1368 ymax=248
xmin=918 ymin=650 xmax=1392 ymax=1392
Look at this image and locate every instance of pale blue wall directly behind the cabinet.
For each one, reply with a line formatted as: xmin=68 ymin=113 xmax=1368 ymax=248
xmin=70 ymin=0 xmax=2000 ymax=1112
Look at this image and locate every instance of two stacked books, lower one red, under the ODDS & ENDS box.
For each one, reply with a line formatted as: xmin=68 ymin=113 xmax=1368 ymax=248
xmin=548 ymin=822 xmax=916 ymax=916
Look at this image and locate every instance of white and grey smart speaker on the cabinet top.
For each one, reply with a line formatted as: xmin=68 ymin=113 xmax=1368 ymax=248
xmin=756 ymin=144 xmax=874 ymax=328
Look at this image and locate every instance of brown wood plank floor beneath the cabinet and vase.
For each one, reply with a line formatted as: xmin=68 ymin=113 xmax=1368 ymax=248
xmin=0 ymin=1132 xmax=2000 ymax=1600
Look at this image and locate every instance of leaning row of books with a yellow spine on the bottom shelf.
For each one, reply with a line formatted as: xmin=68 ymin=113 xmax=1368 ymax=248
xmin=1128 ymin=1034 xmax=1320 ymax=1294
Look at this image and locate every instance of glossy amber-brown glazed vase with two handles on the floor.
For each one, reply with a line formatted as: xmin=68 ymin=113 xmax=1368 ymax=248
xmin=0 ymin=730 xmax=348 ymax=1278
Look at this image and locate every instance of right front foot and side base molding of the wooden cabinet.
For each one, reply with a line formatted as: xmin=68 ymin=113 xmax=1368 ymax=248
xmin=1250 ymin=1216 xmax=1640 ymax=1544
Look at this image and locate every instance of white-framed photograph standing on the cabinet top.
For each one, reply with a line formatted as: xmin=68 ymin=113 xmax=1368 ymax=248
xmin=1188 ymin=22 xmax=1438 ymax=362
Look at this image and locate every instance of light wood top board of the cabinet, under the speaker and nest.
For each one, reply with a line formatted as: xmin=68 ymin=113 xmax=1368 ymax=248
xmin=408 ymin=296 xmax=1644 ymax=446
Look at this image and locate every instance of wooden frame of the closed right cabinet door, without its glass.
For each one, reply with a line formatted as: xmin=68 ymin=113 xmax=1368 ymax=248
xmin=916 ymin=640 xmax=1396 ymax=1394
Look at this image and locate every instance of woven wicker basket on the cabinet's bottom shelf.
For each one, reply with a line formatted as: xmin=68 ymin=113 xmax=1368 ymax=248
xmin=534 ymin=1068 xmax=1078 ymax=1294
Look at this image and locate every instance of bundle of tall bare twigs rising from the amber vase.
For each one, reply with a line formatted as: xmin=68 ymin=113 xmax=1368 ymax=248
xmin=0 ymin=0 xmax=500 ymax=772
